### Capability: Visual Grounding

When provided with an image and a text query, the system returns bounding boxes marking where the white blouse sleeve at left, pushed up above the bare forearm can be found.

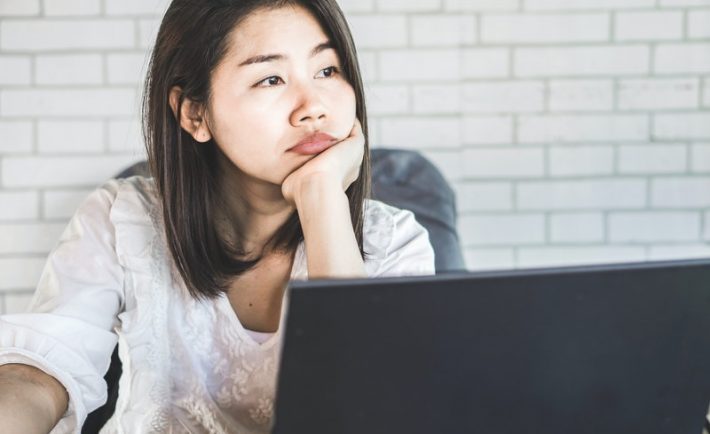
[0,181,123,434]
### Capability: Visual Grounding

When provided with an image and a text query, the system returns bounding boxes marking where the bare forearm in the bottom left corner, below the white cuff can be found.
[0,364,69,433]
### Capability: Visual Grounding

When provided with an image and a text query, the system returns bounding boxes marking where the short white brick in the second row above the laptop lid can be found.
[550,213,605,243]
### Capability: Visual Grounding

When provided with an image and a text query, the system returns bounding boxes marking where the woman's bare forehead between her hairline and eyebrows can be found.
[230,5,328,58]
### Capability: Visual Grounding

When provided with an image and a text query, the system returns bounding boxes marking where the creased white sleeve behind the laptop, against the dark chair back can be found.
[368,208,435,277]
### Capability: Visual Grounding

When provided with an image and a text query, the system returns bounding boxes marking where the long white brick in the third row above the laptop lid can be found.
[516,178,647,210]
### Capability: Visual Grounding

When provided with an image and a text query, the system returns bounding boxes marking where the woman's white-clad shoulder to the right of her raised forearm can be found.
[363,199,434,276]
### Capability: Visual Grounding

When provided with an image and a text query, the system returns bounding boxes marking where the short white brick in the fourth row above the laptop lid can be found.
[548,146,614,176]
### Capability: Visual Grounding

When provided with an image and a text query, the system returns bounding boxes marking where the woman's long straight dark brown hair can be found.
[142,0,370,299]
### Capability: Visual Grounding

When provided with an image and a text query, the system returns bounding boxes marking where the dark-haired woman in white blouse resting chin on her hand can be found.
[0,0,434,433]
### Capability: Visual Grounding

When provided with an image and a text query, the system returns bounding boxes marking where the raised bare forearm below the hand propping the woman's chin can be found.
[295,175,366,279]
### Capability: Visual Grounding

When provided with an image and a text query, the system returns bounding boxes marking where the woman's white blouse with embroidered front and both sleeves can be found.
[0,177,434,434]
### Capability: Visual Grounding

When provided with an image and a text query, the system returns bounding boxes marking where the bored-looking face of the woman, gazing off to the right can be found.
[206,6,356,185]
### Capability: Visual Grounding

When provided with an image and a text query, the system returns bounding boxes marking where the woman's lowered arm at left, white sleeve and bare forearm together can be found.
[0,181,123,433]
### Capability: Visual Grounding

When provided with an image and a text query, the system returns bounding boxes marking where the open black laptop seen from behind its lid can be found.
[273,260,710,434]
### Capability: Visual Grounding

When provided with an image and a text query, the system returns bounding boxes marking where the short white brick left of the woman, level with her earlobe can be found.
[37,121,104,154]
